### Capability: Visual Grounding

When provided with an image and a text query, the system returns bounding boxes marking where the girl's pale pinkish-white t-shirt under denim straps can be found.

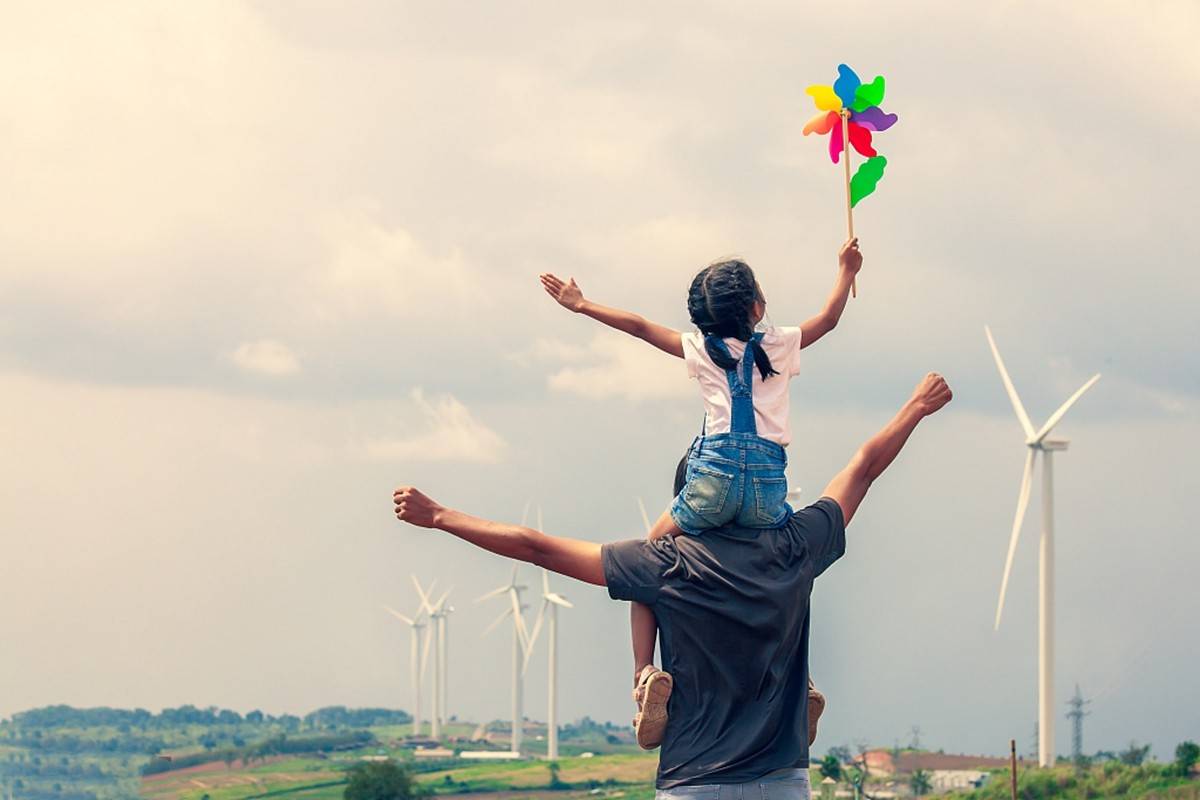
[683,327,800,447]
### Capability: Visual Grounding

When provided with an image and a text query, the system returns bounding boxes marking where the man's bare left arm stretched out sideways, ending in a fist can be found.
[392,486,605,587]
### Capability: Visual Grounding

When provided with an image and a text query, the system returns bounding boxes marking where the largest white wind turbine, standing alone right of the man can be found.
[983,325,1100,766]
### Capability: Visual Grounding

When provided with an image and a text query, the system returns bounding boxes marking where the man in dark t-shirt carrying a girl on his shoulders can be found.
[392,373,952,800]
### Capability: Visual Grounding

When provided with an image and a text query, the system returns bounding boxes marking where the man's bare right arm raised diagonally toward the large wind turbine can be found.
[824,372,954,525]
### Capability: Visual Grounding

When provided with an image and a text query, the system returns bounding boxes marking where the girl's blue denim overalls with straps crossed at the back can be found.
[671,333,792,534]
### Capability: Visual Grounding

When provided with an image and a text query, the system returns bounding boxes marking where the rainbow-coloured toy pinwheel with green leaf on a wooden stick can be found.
[804,64,898,296]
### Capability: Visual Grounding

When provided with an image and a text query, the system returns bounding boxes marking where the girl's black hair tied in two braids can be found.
[688,259,779,380]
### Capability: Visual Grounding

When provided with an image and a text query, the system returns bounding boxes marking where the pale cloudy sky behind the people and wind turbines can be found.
[0,0,1200,758]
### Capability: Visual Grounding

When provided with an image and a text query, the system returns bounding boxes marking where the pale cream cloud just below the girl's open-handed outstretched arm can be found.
[542,332,694,401]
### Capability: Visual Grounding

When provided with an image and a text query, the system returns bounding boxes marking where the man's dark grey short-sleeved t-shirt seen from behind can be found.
[604,498,846,789]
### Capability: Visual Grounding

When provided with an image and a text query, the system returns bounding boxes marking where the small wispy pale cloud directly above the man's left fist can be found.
[365,389,506,464]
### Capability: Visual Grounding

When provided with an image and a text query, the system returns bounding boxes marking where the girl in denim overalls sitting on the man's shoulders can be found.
[541,239,863,748]
